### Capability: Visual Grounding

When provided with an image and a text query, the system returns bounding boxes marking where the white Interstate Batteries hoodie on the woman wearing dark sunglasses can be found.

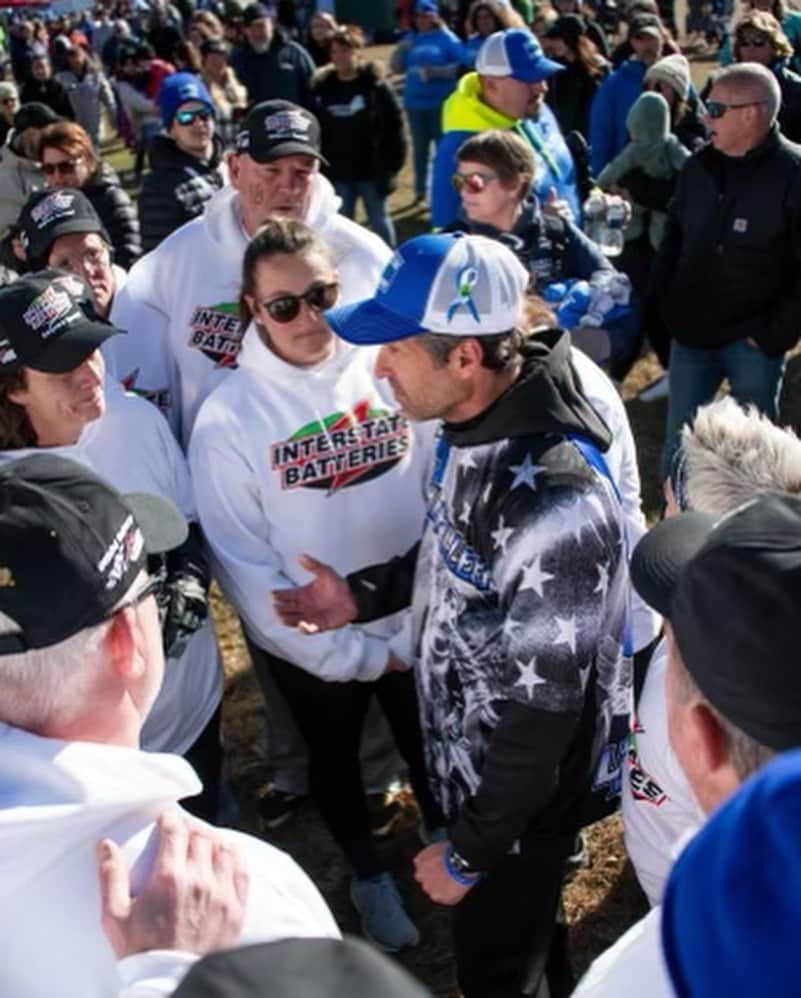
[189,325,433,681]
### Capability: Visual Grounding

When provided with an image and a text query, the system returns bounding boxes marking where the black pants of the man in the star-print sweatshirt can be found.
[453,836,574,998]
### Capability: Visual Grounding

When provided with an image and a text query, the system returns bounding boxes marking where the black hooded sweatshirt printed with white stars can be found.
[348,331,631,870]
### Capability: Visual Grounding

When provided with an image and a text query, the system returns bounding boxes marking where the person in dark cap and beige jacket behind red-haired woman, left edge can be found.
[0,104,58,236]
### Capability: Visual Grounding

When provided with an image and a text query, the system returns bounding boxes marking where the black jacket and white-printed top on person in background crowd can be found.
[311,62,406,195]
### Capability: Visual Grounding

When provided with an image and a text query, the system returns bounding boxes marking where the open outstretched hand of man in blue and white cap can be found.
[272,554,357,634]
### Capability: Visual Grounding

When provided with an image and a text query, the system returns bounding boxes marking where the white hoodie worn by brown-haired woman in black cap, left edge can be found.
[0,380,222,756]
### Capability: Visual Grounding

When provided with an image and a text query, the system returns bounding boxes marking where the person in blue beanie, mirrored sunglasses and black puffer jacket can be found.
[137,73,225,253]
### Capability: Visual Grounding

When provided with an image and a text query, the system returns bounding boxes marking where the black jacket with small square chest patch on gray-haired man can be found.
[648,126,801,357]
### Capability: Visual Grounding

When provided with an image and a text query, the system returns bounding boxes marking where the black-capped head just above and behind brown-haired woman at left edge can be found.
[18,187,117,319]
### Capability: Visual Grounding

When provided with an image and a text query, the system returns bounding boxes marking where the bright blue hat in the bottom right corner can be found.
[664,750,801,998]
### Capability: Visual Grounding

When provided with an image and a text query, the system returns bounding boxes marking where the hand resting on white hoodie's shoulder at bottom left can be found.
[97,811,249,959]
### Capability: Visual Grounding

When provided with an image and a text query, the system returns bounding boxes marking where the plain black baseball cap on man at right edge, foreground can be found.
[631,494,801,751]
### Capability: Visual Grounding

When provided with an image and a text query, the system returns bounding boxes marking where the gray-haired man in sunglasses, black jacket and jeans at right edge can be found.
[648,63,801,478]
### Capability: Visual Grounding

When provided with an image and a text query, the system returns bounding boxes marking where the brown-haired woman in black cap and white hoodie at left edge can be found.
[0,269,222,821]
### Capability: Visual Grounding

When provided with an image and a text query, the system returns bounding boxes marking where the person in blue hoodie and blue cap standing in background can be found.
[390,0,464,201]
